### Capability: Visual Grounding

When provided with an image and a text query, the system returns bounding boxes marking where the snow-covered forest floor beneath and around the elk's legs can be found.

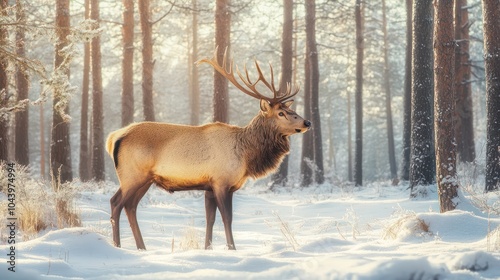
[0,182,500,280]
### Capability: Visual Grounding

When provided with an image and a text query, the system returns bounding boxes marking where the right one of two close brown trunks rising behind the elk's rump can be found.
[139,0,155,121]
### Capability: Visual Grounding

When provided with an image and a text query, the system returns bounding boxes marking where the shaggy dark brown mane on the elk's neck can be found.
[236,114,290,178]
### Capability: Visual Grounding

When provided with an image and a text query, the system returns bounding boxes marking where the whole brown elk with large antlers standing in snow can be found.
[106,49,311,250]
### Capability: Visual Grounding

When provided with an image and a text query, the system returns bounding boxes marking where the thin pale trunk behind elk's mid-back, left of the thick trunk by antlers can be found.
[190,0,200,125]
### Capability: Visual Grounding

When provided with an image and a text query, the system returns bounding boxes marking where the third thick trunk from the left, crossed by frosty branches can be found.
[50,0,73,183]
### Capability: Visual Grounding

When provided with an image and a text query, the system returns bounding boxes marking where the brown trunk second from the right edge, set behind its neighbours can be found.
[455,0,476,162]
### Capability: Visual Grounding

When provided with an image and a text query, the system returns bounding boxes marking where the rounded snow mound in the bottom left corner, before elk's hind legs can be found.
[0,228,145,279]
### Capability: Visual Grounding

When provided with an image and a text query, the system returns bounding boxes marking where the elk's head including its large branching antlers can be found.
[196,48,311,136]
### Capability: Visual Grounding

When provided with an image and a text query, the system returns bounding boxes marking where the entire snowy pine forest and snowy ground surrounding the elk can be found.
[0,0,500,279]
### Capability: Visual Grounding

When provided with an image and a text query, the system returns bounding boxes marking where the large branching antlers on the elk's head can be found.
[196,47,300,105]
